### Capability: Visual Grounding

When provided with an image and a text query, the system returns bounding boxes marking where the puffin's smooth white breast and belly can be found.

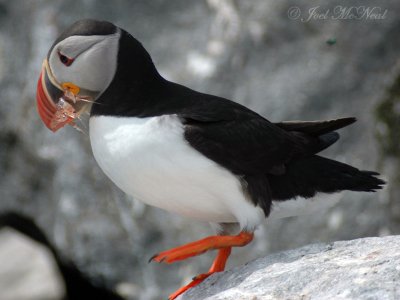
[90,115,264,229]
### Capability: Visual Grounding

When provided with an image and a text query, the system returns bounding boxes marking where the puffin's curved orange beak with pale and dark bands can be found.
[36,60,74,132]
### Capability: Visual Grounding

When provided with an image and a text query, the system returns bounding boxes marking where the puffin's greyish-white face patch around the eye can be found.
[49,31,120,92]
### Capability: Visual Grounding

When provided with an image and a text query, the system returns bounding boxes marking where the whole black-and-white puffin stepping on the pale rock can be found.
[36,19,385,299]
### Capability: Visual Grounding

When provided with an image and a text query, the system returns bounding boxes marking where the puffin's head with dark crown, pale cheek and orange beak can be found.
[36,20,121,131]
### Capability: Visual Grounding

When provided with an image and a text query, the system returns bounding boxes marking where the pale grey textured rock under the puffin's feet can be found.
[181,236,400,300]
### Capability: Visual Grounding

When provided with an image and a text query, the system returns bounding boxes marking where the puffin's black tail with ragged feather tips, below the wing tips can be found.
[268,155,385,200]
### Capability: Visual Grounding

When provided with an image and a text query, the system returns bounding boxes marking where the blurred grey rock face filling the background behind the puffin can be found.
[0,0,400,299]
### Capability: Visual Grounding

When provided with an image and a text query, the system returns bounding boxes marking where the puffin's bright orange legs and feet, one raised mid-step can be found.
[150,231,254,300]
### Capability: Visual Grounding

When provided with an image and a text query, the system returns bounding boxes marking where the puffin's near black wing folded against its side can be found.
[179,95,337,176]
